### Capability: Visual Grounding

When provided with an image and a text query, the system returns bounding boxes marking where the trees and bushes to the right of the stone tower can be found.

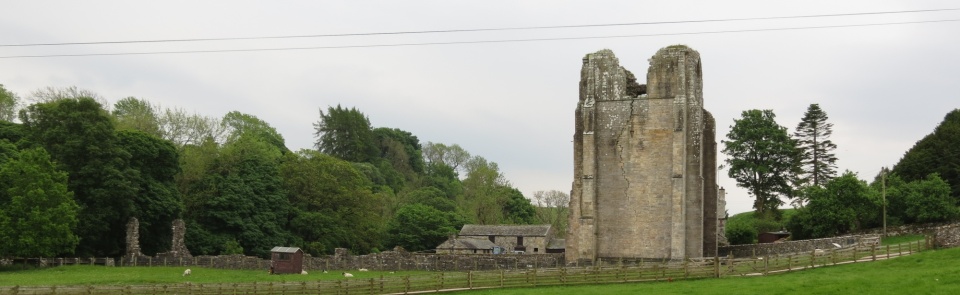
[723,104,960,244]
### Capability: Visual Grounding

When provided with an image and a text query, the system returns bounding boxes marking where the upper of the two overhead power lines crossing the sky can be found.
[0,8,960,47]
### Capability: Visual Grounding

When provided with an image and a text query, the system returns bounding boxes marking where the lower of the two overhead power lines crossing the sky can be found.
[0,19,960,59]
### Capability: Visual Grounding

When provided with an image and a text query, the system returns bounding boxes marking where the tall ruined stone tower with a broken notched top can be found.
[566,45,717,263]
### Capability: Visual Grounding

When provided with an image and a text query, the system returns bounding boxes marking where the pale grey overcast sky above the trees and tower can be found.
[0,0,960,214]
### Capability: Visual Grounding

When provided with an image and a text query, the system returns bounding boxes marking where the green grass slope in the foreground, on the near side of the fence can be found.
[455,248,960,295]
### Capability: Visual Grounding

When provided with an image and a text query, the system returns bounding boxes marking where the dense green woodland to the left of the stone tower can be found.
[0,85,569,257]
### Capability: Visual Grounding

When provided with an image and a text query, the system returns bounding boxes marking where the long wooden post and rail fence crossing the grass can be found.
[0,239,931,295]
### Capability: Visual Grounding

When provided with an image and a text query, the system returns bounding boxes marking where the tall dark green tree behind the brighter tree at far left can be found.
[20,97,137,256]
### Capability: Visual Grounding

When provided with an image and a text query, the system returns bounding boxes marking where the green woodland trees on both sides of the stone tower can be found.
[0,85,960,257]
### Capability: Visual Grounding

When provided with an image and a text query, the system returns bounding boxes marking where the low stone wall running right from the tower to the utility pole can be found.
[717,234,880,257]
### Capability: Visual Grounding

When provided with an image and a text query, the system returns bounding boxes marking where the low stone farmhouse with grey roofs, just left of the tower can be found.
[437,224,565,254]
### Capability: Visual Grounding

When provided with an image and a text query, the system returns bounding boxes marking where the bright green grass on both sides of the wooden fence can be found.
[0,236,948,295]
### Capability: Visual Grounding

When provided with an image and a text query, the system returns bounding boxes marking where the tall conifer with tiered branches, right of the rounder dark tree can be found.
[793,103,837,186]
